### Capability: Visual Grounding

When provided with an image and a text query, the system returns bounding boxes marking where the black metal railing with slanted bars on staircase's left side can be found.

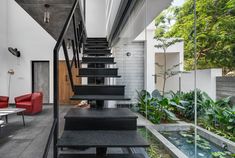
[43,0,86,158]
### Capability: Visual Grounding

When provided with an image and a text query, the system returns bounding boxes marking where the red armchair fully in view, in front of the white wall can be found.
[15,92,43,115]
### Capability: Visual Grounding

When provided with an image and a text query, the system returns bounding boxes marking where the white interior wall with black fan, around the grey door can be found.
[4,0,71,103]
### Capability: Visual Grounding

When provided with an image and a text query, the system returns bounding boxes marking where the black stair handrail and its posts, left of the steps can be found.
[43,0,86,158]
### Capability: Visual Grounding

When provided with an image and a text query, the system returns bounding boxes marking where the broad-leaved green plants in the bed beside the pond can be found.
[137,89,235,141]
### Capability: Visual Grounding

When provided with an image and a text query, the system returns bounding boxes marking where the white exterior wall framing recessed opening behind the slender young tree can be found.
[135,21,184,92]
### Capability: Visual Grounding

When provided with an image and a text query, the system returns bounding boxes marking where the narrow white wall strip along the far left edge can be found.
[0,0,8,95]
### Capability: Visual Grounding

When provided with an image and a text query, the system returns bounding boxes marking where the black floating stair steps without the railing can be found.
[58,38,148,158]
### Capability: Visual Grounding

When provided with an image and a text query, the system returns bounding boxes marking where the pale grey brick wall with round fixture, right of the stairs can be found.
[112,42,144,104]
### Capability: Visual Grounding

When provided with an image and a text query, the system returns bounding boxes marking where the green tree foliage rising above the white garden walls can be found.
[156,0,235,74]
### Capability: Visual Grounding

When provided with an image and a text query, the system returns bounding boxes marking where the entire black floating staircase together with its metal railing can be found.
[43,0,149,158]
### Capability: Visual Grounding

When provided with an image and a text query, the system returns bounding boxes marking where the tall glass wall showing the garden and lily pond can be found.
[118,0,235,158]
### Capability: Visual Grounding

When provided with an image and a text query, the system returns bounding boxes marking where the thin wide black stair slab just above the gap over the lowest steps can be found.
[70,95,130,100]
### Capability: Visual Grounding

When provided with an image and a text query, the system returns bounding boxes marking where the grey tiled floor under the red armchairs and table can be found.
[0,105,70,158]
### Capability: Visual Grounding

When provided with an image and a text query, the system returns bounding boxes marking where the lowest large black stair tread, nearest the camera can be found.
[57,130,149,147]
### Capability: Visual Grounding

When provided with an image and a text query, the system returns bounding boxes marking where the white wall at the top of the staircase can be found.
[86,0,106,37]
